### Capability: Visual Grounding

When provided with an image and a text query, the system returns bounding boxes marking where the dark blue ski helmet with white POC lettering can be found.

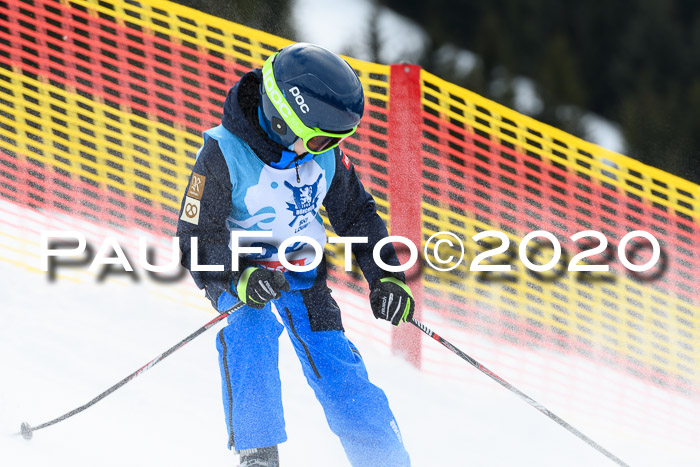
[260,42,365,147]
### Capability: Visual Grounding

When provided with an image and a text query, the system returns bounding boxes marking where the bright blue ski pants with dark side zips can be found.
[217,291,410,467]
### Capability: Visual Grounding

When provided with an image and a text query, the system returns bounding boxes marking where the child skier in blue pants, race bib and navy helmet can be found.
[178,43,414,466]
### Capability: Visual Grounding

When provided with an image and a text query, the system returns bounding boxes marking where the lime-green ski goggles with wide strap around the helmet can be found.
[263,52,357,154]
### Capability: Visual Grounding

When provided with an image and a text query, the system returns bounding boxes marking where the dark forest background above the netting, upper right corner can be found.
[379,0,700,182]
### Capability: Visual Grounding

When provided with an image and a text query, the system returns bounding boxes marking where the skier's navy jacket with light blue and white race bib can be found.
[177,69,403,326]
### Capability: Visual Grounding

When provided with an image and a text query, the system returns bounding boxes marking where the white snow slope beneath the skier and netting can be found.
[0,202,700,467]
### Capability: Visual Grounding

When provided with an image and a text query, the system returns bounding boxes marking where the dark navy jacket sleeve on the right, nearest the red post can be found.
[323,148,405,285]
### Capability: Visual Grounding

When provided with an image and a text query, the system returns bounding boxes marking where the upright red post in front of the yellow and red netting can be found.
[387,64,423,368]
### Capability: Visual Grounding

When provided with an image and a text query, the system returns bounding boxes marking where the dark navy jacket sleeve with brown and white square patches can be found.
[177,139,254,302]
